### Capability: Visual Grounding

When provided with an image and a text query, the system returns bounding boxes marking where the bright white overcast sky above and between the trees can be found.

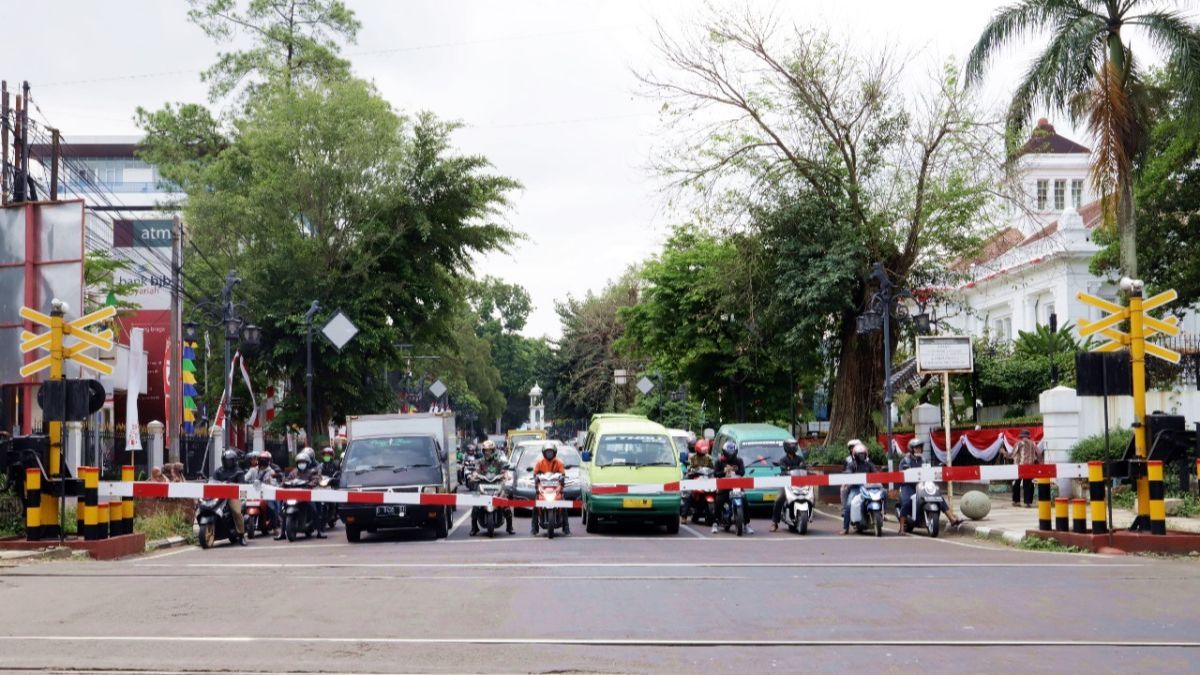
[9,0,1180,336]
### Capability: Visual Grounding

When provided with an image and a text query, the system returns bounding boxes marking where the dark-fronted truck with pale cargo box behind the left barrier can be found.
[338,413,457,542]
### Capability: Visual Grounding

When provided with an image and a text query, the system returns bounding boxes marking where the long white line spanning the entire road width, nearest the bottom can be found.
[0,635,1200,649]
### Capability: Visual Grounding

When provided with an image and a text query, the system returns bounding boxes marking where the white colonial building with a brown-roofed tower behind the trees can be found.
[946,119,1200,340]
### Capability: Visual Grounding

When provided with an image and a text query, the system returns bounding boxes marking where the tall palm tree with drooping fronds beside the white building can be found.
[966,0,1200,279]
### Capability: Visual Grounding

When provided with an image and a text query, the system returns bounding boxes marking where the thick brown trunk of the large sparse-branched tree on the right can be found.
[829,313,883,441]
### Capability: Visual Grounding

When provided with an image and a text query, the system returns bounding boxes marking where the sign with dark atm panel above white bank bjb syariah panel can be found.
[113,219,174,310]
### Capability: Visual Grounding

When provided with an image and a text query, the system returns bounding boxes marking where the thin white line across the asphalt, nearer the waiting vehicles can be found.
[139,561,1146,569]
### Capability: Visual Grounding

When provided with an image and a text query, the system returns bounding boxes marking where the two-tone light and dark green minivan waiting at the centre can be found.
[580,414,680,534]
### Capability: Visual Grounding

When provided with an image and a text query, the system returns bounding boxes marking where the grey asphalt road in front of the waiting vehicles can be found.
[0,512,1200,673]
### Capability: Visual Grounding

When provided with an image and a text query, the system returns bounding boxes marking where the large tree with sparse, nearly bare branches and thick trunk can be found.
[643,12,997,436]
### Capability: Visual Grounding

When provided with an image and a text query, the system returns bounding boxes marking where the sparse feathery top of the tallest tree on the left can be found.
[187,0,362,101]
